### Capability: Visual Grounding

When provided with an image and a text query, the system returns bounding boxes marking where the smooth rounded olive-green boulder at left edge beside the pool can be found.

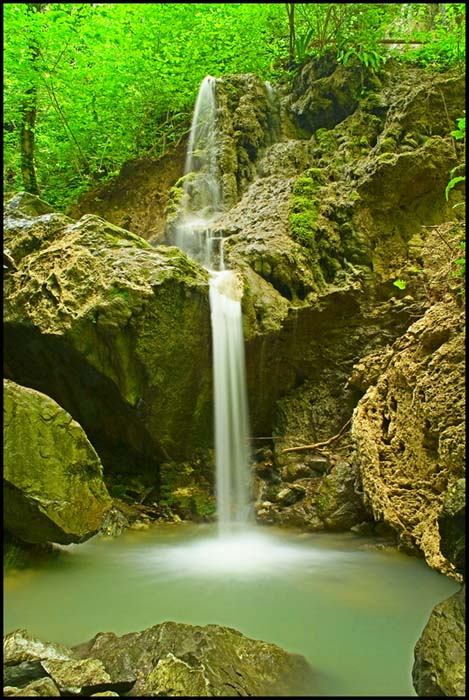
[3,380,111,544]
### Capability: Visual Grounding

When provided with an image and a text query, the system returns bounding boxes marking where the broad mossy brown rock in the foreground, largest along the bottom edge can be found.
[74,622,312,697]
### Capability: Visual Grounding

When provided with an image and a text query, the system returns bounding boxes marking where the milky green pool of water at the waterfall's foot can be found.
[4,524,459,697]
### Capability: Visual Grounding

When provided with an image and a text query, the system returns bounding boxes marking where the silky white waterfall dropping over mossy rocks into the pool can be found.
[176,76,251,534]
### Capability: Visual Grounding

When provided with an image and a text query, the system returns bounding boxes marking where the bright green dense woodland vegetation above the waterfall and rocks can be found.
[4,3,465,209]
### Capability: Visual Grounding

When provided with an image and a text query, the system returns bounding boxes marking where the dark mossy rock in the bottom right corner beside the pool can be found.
[412,587,466,697]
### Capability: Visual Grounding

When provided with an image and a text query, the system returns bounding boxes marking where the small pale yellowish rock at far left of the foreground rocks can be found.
[3,629,76,666]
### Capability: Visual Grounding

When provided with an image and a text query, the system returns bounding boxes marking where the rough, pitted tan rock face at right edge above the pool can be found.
[352,296,465,574]
